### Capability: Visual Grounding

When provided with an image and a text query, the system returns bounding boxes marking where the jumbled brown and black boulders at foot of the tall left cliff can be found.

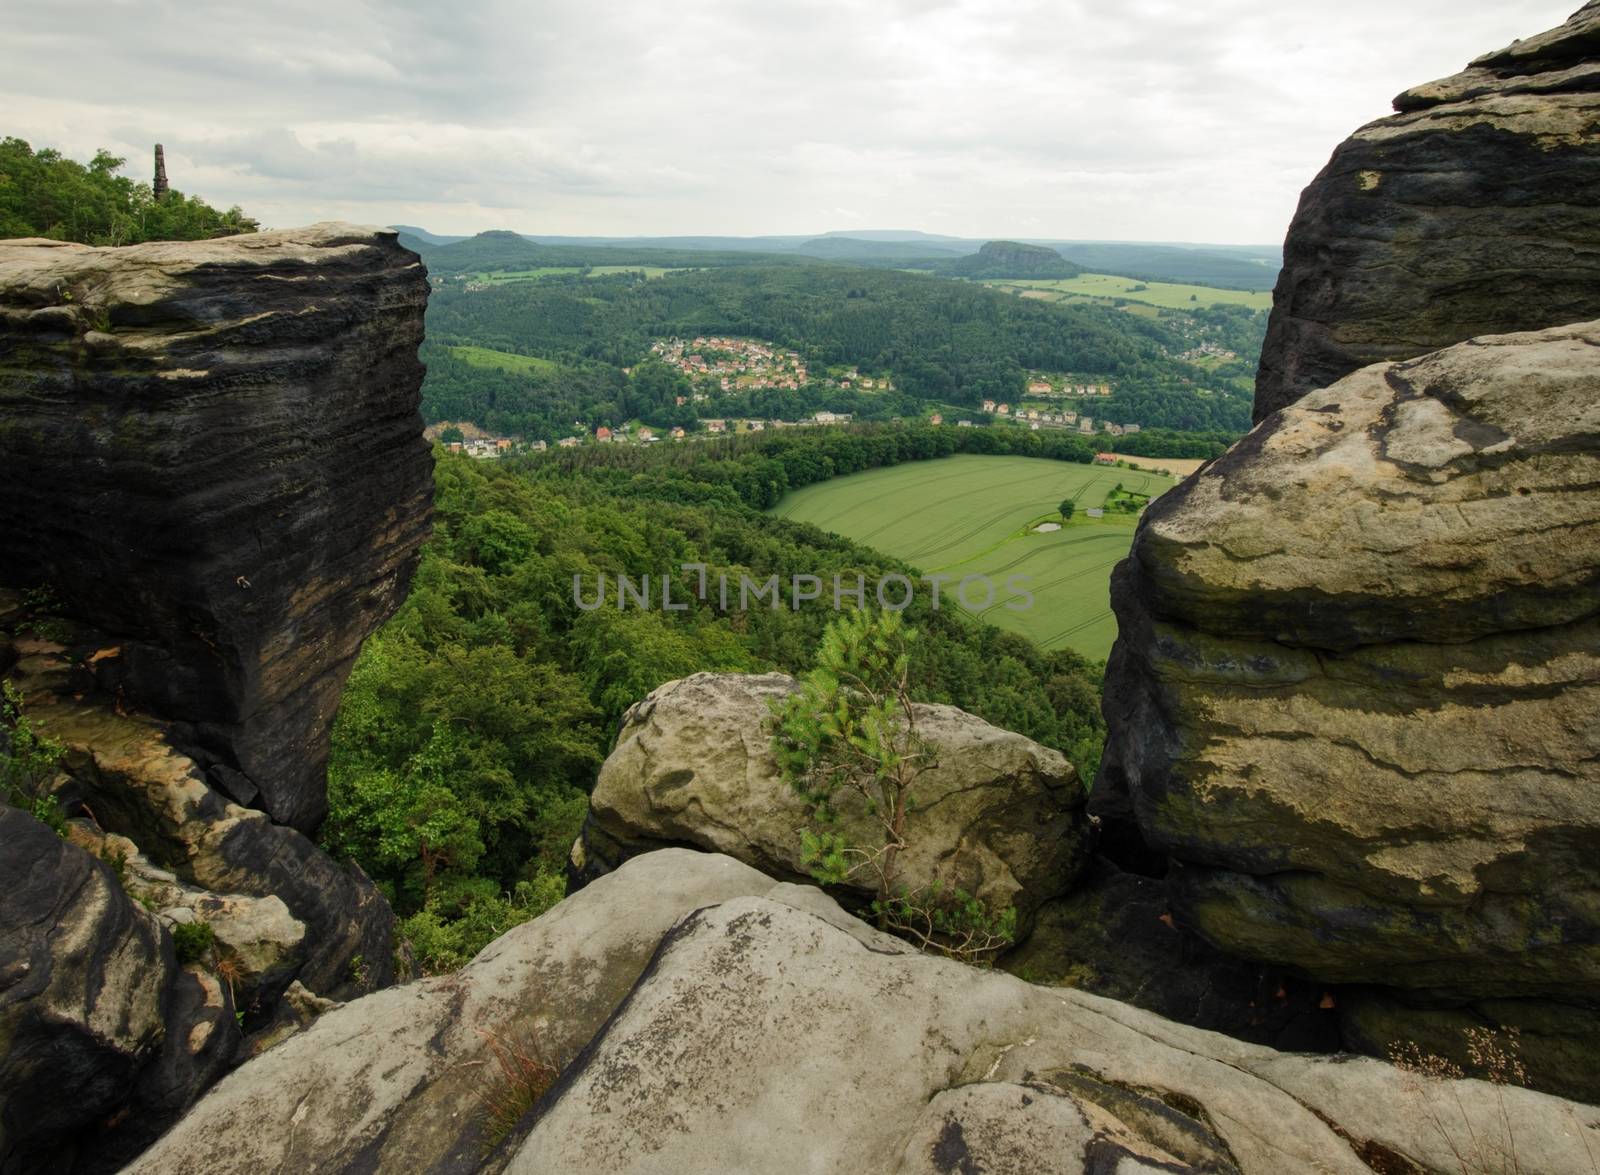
[0,591,395,1175]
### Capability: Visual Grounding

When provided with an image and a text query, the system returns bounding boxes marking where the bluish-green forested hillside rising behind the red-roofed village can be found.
[429,263,1248,427]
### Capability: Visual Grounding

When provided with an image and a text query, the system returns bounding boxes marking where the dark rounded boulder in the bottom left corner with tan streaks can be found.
[0,804,238,1172]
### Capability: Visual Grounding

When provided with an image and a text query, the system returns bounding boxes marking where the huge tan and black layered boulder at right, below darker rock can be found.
[1091,323,1600,1098]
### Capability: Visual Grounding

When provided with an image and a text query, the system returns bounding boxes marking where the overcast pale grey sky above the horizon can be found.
[0,0,1579,243]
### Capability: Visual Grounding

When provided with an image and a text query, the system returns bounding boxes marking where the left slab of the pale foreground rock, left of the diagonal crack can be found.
[121,850,796,1172]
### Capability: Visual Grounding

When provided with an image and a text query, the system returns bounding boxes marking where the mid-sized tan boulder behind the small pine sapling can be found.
[574,674,1088,924]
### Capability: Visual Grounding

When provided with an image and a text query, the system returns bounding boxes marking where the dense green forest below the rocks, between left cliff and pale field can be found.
[323,427,1102,970]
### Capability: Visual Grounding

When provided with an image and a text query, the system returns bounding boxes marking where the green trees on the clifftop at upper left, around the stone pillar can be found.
[0,138,256,245]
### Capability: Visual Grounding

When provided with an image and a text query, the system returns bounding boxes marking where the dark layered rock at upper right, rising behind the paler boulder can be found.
[1256,3,1600,421]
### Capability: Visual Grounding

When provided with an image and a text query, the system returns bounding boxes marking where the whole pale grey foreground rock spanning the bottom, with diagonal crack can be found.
[130,850,1600,1175]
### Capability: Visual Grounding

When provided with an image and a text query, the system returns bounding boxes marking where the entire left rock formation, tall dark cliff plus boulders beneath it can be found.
[0,226,430,1175]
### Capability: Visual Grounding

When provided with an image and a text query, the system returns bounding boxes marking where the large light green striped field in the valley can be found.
[773,455,1176,660]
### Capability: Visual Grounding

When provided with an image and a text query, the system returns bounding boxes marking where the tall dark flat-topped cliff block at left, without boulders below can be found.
[0,224,432,831]
